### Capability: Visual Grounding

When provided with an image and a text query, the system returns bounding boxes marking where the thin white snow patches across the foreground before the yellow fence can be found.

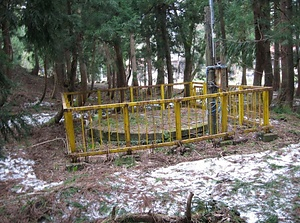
[0,143,300,223]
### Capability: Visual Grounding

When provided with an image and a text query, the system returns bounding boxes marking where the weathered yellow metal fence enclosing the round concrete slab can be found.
[62,82,270,157]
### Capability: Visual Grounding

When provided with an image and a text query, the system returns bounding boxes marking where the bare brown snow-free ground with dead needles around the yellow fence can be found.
[0,69,300,222]
